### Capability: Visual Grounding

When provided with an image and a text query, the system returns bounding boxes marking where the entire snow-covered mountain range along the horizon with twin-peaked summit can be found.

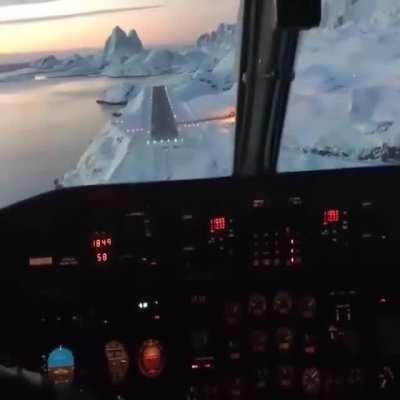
[0,24,239,84]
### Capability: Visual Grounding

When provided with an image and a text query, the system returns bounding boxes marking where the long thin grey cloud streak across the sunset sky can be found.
[0,4,163,25]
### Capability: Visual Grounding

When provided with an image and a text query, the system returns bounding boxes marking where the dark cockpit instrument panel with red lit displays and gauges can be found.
[0,167,400,400]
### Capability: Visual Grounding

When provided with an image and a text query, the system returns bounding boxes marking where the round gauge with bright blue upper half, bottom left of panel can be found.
[47,346,75,385]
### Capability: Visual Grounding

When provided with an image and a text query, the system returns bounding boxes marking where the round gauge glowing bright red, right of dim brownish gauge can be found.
[138,339,166,379]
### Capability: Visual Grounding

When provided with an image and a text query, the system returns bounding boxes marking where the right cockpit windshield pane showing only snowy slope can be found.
[278,0,400,172]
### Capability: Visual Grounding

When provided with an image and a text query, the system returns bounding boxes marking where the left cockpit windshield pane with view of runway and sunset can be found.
[0,0,241,207]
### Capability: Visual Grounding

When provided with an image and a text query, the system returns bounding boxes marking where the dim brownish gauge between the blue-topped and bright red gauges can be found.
[105,341,129,385]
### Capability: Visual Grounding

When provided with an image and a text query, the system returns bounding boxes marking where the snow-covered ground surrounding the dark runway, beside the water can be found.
[62,80,236,186]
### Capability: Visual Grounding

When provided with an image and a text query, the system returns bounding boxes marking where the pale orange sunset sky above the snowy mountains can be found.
[0,0,240,60]
